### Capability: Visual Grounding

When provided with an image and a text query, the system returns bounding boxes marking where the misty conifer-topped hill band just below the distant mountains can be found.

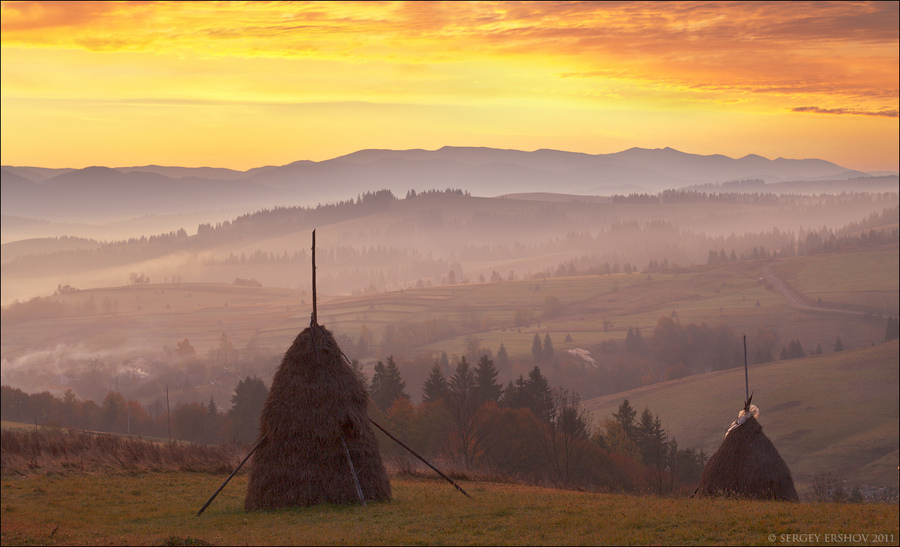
[2,188,897,304]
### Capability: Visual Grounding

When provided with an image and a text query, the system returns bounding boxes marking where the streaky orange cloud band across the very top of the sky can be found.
[2,2,900,109]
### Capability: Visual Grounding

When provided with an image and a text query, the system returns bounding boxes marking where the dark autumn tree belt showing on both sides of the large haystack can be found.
[2,355,706,493]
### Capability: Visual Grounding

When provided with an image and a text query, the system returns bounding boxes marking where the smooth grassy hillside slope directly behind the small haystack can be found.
[585,340,900,491]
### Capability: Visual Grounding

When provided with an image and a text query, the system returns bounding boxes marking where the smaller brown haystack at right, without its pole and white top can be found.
[695,417,799,501]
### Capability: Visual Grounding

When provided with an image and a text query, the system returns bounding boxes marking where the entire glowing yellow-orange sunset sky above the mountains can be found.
[0,2,900,171]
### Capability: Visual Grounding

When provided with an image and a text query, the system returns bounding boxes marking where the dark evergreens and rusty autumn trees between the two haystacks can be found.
[342,354,706,493]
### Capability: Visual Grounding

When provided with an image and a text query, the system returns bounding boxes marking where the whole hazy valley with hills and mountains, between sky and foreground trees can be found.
[2,147,900,492]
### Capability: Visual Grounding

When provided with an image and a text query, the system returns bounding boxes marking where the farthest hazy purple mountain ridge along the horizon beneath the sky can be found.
[2,146,892,221]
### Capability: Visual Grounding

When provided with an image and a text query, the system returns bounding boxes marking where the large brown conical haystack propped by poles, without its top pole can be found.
[244,325,391,511]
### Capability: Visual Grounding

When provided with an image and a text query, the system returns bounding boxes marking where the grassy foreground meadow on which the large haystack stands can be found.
[0,473,900,545]
